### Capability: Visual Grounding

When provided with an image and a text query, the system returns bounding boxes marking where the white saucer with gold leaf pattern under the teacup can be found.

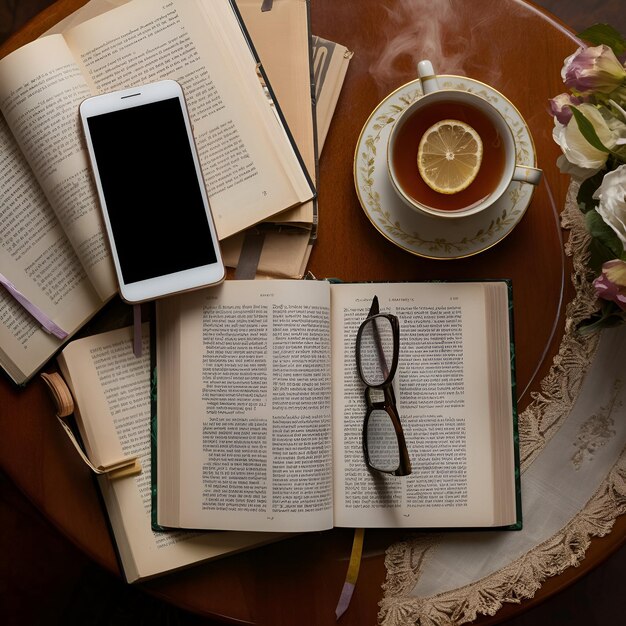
[354,76,536,259]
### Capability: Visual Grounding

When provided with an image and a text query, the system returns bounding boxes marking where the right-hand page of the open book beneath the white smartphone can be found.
[64,0,313,238]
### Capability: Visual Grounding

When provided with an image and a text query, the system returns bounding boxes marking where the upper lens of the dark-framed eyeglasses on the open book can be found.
[359,317,394,386]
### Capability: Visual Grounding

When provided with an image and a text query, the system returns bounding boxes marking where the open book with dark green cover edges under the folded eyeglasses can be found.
[153,280,521,532]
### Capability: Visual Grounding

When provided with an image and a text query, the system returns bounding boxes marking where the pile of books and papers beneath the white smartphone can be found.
[0,0,349,384]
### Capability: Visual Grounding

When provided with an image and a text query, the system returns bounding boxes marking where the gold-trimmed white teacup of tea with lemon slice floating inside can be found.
[387,60,542,218]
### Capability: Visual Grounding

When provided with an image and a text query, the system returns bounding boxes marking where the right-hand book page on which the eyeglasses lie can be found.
[331,283,515,528]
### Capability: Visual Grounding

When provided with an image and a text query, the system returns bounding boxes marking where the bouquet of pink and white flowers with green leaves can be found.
[550,24,626,332]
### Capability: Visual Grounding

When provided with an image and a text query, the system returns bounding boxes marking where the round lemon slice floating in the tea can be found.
[417,120,483,194]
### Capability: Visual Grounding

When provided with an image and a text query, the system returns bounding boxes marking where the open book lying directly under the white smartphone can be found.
[0,0,314,382]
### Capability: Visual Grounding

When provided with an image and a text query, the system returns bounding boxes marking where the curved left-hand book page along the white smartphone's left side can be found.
[0,35,117,300]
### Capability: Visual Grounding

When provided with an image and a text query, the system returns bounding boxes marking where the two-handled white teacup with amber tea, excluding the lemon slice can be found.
[387,60,542,218]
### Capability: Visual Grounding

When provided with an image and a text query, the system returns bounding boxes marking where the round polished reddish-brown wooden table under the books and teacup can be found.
[0,0,626,625]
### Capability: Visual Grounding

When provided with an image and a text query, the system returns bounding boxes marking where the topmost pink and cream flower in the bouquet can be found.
[561,44,626,94]
